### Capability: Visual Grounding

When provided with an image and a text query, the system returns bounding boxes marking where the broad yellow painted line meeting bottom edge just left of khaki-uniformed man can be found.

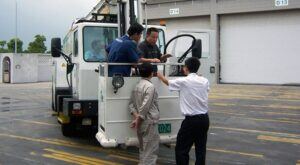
[44,148,119,165]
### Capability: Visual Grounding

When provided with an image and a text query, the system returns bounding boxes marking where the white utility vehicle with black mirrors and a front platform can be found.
[51,0,202,147]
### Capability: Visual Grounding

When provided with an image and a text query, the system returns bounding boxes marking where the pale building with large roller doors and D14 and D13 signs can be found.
[94,0,300,84]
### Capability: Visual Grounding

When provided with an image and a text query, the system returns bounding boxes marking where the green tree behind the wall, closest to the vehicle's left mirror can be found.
[26,35,47,53]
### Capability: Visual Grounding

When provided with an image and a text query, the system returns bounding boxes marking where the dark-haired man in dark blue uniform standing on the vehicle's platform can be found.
[106,23,144,77]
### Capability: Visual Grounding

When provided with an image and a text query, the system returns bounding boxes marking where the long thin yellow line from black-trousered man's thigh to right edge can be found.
[210,126,300,138]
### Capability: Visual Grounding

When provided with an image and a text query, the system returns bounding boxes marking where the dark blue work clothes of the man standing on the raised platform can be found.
[106,35,139,77]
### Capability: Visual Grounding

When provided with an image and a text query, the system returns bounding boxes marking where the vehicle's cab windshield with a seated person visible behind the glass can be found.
[83,26,118,62]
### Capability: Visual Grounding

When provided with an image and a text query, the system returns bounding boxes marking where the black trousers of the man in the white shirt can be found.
[175,114,209,165]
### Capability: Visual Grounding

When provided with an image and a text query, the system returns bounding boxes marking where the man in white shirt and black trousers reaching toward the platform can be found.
[157,57,209,165]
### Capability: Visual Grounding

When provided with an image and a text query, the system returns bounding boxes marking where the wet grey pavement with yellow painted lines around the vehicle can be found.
[0,83,300,165]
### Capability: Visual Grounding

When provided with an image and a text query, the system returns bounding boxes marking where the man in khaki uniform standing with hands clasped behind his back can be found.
[129,63,159,165]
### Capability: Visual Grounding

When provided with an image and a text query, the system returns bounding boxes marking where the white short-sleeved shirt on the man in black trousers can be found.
[169,73,209,116]
